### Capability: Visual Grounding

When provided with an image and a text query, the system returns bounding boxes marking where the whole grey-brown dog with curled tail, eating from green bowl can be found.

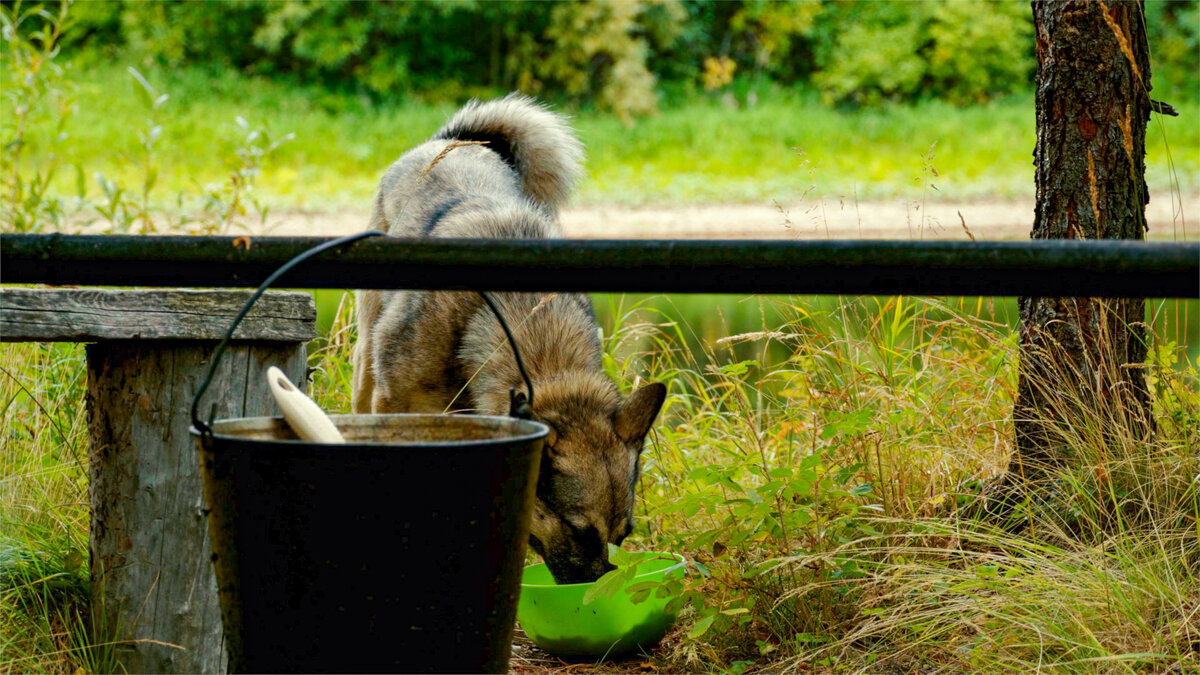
[352,95,666,584]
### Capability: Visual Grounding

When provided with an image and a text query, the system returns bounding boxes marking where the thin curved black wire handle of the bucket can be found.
[191,229,533,438]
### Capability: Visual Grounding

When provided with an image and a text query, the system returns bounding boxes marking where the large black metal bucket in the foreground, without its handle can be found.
[193,414,548,673]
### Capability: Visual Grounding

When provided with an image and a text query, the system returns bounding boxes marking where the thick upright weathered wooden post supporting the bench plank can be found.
[88,340,306,673]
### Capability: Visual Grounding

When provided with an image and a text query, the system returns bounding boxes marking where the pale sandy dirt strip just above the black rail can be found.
[268,193,1200,240]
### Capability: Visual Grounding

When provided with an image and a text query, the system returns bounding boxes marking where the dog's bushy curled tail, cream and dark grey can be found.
[433,94,583,208]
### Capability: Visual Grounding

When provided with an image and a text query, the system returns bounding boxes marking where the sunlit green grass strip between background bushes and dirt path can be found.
[28,61,1200,209]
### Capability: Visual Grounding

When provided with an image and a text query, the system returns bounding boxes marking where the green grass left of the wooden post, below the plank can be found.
[0,345,94,673]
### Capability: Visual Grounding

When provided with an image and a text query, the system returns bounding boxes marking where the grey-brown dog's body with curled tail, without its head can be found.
[353,95,599,414]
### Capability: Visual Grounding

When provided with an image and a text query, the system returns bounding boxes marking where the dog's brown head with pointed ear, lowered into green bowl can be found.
[529,380,666,584]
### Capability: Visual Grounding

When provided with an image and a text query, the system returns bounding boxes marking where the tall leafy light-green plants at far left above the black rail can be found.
[0,2,293,233]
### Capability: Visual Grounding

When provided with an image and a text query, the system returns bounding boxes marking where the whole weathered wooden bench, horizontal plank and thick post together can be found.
[0,288,316,673]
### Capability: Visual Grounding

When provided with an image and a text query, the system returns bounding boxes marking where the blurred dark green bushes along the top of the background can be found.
[54,0,1200,115]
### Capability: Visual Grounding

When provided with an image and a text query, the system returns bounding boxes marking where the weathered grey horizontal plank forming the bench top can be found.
[0,288,317,342]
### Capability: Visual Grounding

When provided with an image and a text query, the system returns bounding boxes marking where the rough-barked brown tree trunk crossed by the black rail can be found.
[1012,0,1153,478]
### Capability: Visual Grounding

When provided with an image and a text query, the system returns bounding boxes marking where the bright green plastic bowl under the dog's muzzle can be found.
[517,551,684,658]
